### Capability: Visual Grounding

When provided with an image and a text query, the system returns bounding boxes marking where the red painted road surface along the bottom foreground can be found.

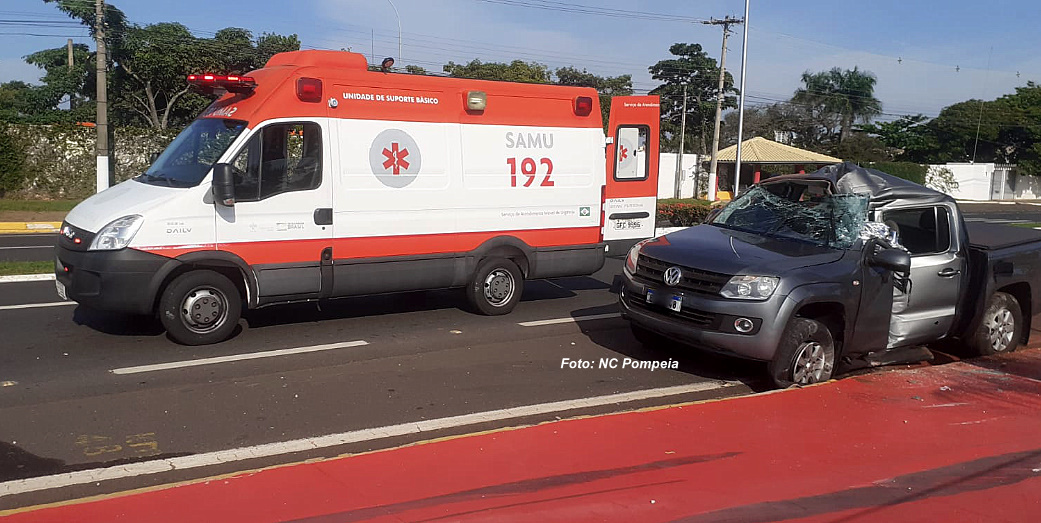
[2,350,1041,522]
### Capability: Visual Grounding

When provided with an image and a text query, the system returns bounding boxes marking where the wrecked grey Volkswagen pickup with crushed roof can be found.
[619,164,1041,387]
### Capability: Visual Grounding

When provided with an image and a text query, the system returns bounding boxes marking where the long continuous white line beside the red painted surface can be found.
[0,381,739,497]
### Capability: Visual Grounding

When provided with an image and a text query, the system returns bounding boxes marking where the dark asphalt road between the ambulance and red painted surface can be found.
[0,259,765,508]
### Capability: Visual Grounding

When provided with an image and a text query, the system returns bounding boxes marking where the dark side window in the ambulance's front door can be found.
[232,123,322,201]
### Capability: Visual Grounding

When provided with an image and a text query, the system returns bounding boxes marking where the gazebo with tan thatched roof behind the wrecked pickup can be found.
[703,136,842,197]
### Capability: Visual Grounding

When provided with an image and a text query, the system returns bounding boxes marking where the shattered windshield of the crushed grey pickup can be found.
[711,183,868,249]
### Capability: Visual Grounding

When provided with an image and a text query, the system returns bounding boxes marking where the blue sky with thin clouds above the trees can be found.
[0,0,1041,120]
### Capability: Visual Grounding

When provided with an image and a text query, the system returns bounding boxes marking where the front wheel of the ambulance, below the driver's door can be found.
[159,271,243,345]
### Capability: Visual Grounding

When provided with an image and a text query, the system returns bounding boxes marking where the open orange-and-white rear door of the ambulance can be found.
[603,96,661,255]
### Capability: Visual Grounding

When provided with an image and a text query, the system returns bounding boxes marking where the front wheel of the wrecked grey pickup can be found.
[769,318,835,389]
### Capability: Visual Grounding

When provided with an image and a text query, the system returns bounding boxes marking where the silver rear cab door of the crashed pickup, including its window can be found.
[882,204,966,348]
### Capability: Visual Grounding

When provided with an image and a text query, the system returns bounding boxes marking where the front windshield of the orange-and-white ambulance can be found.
[134,118,246,188]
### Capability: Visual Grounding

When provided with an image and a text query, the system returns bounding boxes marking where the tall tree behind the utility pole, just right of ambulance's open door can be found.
[649,44,737,154]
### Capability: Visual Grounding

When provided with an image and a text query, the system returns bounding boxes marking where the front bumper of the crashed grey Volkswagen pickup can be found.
[618,273,788,362]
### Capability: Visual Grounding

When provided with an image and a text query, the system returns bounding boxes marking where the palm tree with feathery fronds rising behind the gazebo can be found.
[791,67,882,143]
